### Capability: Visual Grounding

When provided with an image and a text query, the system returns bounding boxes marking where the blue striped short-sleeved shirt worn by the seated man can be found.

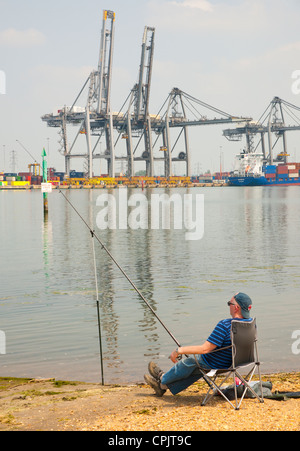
[202,318,252,369]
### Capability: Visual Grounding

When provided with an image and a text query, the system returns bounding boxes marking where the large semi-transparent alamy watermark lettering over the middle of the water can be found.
[96,188,204,241]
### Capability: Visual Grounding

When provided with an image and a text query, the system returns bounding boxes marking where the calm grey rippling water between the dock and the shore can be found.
[0,187,300,383]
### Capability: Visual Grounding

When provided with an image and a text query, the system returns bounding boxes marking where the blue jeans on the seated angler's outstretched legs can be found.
[161,355,210,395]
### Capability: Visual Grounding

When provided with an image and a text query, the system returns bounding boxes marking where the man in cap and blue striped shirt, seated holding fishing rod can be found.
[144,293,252,396]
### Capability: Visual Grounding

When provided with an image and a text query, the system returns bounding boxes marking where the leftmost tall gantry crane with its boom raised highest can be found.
[42,10,115,177]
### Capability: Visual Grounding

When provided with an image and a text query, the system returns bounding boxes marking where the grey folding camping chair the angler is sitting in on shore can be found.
[199,319,264,410]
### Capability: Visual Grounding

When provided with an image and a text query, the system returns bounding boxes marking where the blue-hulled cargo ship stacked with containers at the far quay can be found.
[228,152,300,186]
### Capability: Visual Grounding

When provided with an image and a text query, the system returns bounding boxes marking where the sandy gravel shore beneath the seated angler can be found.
[0,373,300,431]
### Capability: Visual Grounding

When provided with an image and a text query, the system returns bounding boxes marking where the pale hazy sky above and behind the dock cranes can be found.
[0,0,300,172]
